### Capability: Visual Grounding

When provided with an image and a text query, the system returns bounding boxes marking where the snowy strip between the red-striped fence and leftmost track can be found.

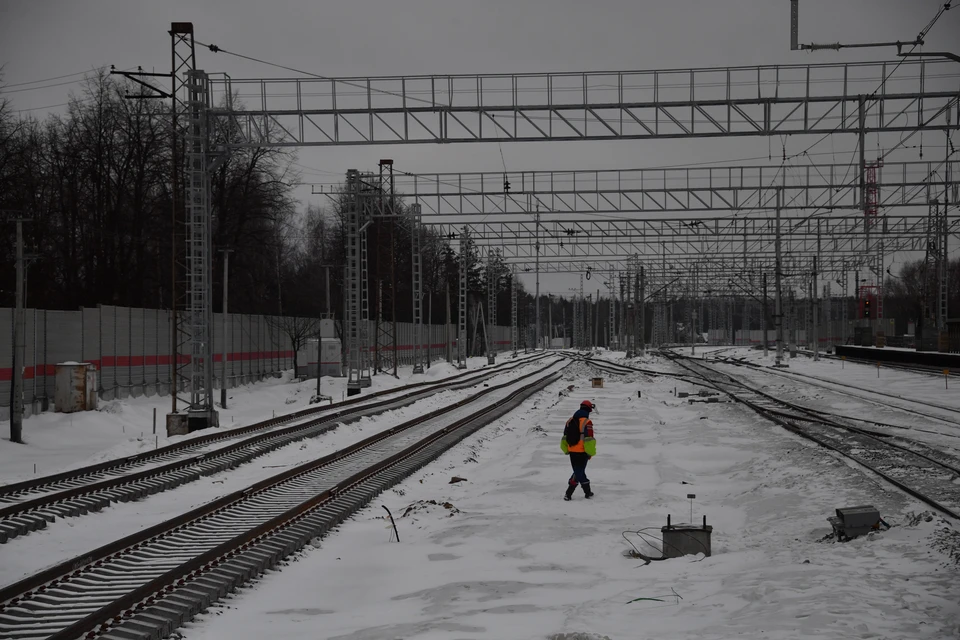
[0,358,503,484]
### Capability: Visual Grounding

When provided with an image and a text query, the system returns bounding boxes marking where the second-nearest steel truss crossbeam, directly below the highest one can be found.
[396,160,960,220]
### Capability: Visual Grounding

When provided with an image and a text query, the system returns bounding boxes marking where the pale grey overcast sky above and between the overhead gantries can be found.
[0,0,960,292]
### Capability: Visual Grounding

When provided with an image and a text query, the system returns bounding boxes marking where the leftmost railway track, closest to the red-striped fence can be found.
[0,356,544,544]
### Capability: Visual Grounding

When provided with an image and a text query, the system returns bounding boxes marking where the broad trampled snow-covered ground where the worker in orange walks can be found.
[171,354,960,640]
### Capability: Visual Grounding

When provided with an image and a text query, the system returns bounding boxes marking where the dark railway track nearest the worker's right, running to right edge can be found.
[668,354,960,519]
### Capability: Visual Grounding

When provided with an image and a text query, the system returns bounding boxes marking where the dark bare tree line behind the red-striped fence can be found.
[0,70,529,340]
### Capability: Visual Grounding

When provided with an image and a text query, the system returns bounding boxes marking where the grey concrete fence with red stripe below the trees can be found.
[0,305,510,418]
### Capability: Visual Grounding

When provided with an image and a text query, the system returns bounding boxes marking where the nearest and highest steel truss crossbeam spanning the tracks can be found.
[206,59,960,146]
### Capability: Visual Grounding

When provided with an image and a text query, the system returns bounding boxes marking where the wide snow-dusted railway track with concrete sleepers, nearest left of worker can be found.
[0,361,569,640]
